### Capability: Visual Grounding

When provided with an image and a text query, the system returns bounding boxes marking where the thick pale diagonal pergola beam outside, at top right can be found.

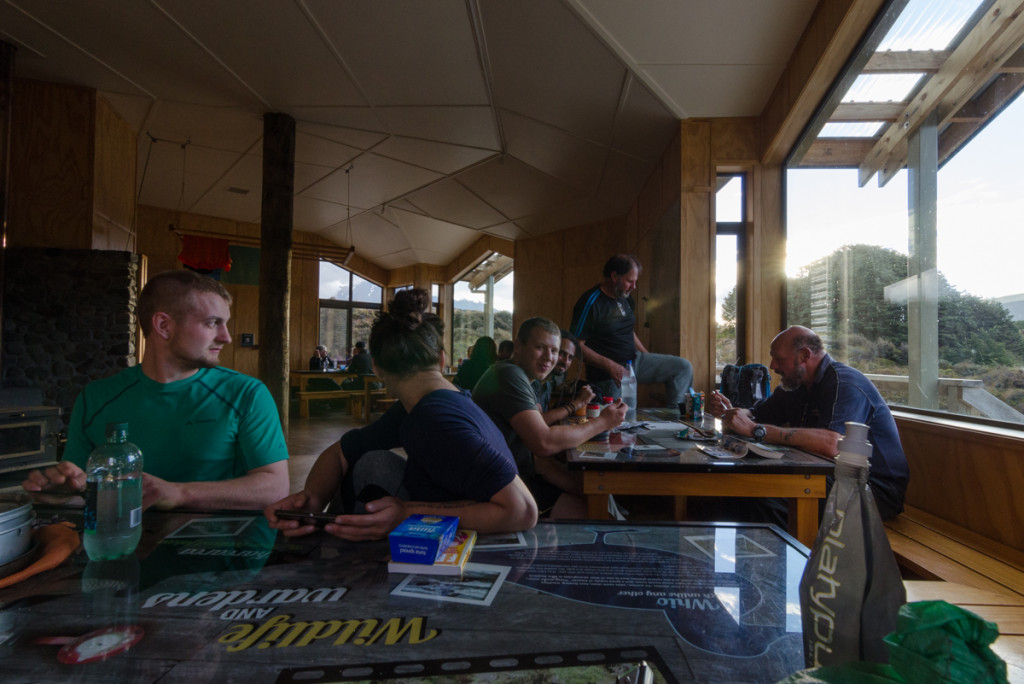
[858,0,1024,186]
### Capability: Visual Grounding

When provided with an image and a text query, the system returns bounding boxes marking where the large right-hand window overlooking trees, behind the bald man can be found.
[786,98,1024,424]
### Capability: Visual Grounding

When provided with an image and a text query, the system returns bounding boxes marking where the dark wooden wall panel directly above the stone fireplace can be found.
[7,79,95,249]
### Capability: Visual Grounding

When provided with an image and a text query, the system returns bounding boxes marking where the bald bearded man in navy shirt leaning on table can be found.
[708,326,910,520]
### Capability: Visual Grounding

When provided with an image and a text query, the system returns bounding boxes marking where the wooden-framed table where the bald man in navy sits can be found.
[566,410,835,547]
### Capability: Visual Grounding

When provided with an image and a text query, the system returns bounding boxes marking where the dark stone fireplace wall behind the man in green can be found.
[0,248,139,426]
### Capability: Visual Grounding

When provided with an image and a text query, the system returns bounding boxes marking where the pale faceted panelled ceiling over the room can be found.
[0,0,817,268]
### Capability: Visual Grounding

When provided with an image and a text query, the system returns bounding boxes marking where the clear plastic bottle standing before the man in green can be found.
[82,423,142,560]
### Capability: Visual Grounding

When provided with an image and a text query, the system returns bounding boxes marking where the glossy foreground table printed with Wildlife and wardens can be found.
[0,513,807,684]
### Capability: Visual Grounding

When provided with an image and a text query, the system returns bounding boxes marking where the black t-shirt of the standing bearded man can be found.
[569,285,637,382]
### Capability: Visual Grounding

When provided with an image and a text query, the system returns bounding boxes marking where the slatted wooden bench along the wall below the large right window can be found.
[886,506,1024,596]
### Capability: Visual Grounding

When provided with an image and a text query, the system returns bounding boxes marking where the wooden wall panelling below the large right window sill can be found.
[896,412,1024,551]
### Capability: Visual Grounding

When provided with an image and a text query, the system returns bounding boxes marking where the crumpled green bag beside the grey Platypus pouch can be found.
[885,601,1007,684]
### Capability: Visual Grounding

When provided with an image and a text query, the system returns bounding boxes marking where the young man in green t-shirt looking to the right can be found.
[23,270,289,509]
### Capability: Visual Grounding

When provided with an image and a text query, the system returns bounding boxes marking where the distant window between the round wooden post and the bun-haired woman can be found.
[319,261,382,362]
